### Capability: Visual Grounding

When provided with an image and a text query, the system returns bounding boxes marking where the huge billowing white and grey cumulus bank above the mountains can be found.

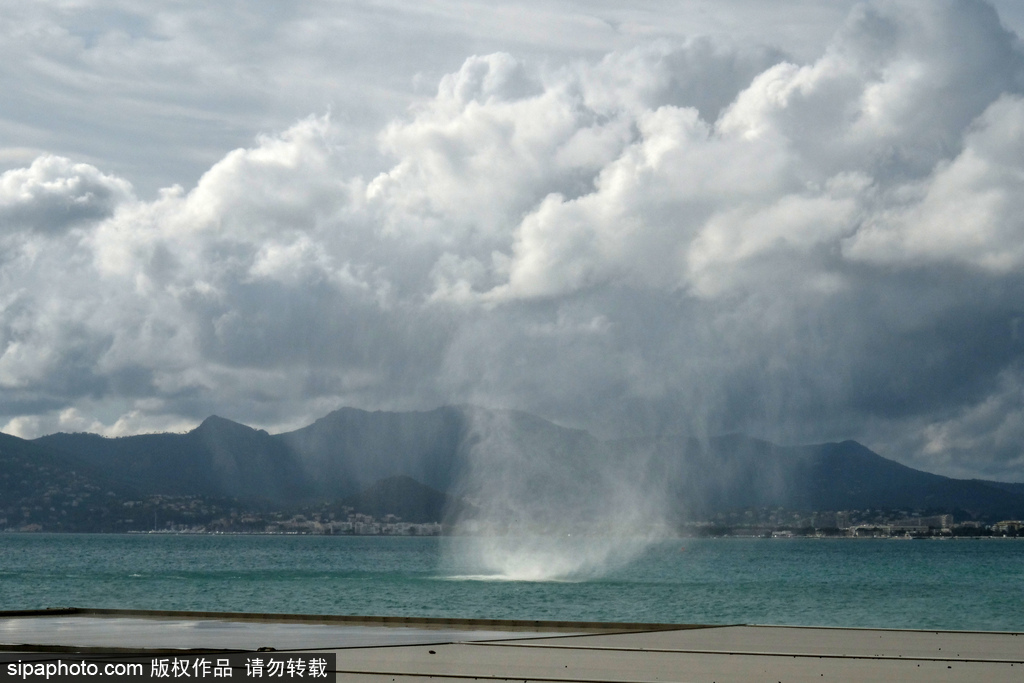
[6,0,1024,478]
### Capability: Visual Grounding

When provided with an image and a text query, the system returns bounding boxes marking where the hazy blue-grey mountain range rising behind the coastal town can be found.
[19,405,1024,519]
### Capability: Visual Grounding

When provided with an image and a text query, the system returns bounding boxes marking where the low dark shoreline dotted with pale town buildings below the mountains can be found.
[0,489,1024,539]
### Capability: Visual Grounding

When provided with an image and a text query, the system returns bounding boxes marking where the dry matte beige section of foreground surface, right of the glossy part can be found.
[325,626,1024,683]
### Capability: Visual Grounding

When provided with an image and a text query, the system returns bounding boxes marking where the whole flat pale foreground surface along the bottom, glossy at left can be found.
[0,609,1024,683]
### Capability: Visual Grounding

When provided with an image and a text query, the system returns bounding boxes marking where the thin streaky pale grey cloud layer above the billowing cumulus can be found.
[0,0,868,199]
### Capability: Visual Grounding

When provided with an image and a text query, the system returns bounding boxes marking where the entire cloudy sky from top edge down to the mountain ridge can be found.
[0,0,1024,481]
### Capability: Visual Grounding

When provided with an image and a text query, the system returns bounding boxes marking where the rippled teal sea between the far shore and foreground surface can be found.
[0,533,1024,631]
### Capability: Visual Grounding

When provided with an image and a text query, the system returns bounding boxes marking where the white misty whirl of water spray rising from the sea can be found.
[447,411,667,582]
